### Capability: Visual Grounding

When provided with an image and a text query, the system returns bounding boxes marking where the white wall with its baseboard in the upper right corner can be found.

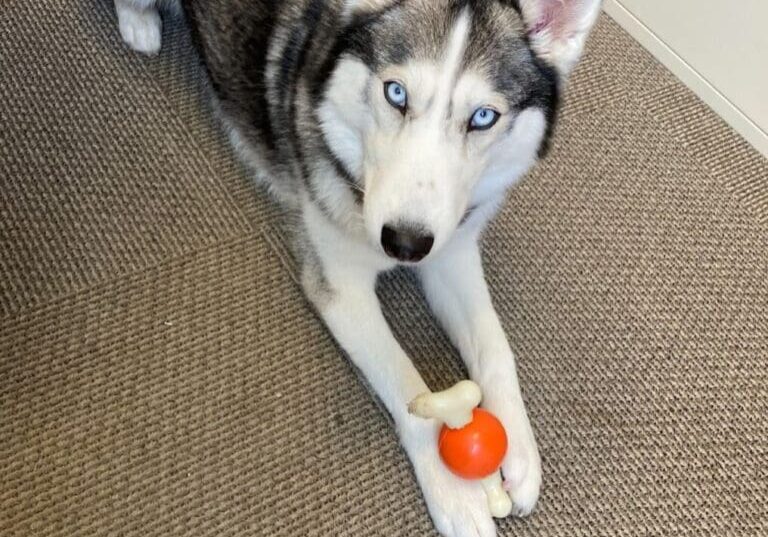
[605,0,768,156]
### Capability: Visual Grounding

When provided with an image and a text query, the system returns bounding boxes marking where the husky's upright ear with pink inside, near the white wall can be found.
[519,0,602,77]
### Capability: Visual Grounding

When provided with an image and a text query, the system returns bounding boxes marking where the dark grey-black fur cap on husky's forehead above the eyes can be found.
[313,0,560,156]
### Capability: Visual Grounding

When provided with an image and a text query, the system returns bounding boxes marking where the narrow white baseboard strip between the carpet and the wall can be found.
[603,0,768,157]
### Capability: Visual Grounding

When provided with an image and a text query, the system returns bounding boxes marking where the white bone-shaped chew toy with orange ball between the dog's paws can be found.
[408,380,512,518]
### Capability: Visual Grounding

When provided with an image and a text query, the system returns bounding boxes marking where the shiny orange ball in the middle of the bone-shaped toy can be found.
[438,408,507,479]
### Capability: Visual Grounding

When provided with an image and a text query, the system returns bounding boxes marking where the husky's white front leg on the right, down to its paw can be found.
[419,234,541,516]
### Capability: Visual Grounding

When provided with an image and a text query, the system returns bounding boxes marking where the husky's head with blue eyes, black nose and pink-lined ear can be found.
[320,0,600,262]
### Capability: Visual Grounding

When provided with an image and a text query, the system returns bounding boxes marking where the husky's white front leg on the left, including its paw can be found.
[302,219,496,537]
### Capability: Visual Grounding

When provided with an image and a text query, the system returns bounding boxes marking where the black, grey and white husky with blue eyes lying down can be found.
[115,0,600,537]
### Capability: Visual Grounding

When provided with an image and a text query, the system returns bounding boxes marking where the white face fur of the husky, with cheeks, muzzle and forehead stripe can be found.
[320,10,546,260]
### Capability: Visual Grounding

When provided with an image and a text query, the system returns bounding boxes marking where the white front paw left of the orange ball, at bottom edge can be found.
[411,446,496,537]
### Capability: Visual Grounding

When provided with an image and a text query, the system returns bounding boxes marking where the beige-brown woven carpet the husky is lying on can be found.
[0,0,768,537]
